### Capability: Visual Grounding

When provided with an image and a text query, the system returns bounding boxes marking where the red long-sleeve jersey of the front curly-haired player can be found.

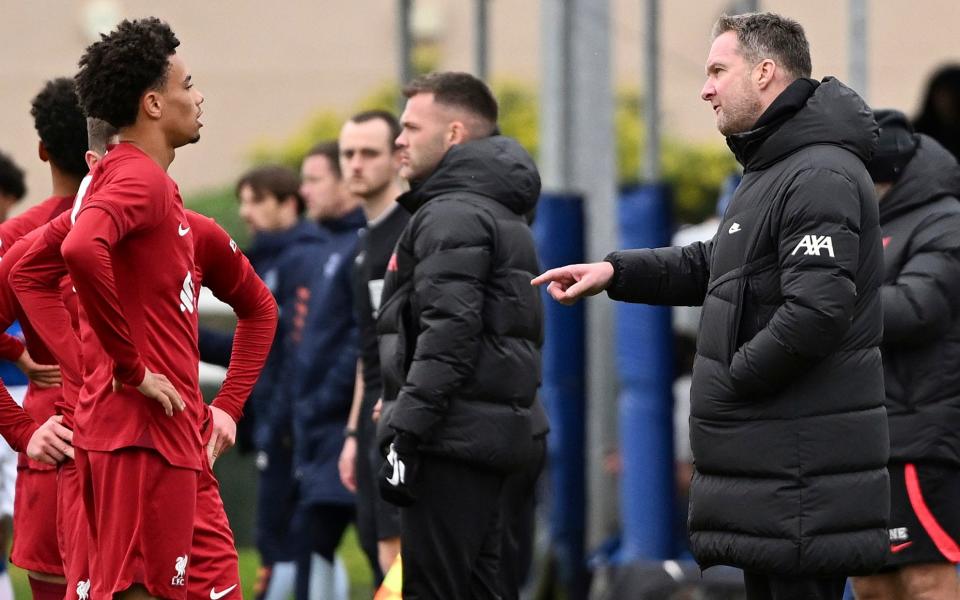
[60,143,204,469]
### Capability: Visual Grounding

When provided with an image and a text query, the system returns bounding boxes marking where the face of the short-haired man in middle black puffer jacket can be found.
[397,93,456,181]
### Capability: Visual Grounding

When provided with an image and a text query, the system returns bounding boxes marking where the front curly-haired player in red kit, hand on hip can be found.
[61,18,204,598]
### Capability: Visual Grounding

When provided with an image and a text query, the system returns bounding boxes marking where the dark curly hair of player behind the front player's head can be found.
[30,77,87,177]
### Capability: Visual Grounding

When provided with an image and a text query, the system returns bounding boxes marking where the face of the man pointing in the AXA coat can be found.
[700,31,763,136]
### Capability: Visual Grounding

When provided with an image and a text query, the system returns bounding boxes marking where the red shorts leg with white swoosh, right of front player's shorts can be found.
[187,455,243,600]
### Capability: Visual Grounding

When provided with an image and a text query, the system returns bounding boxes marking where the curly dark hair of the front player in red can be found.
[76,17,180,128]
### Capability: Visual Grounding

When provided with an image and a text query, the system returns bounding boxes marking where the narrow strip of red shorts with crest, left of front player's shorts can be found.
[57,460,90,600]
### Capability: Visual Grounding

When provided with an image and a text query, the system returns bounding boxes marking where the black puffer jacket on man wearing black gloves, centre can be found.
[377,136,546,471]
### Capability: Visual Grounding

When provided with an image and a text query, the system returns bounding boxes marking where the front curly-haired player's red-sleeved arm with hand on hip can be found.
[60,190,186,416]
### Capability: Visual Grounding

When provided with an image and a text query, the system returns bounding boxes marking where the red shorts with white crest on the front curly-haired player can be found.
[76,448,199,599]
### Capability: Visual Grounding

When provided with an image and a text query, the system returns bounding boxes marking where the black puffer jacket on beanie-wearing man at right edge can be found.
[880,135,960,466]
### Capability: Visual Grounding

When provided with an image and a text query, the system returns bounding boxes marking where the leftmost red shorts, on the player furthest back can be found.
[10,461,63,575]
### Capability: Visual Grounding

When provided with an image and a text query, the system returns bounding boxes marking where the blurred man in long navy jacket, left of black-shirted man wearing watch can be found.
[282,142,367,600]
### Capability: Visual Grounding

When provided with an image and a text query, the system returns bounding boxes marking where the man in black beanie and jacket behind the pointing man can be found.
[854,110,960,600]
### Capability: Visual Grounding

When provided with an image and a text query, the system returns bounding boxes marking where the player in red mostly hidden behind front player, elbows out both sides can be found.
[9,119,277,600]
